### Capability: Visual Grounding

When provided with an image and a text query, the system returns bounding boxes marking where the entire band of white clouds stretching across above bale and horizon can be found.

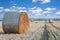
[0,6,60,18]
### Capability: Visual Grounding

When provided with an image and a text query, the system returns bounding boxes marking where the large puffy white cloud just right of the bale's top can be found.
[29,7,43,17]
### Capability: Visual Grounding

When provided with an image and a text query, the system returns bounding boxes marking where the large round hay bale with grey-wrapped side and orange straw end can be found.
[2,12,29,34]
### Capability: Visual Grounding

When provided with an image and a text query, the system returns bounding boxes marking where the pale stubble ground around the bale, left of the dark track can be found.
[0,21,45,40]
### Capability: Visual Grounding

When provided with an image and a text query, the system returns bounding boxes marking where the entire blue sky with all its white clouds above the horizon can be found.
[0,0,60,19]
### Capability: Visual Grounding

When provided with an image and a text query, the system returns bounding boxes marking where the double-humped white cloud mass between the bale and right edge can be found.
[29,6,56,18]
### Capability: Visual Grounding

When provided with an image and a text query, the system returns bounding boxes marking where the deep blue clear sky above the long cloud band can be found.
[0,0,60,9]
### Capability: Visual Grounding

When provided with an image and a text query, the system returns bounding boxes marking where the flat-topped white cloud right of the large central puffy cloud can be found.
[43,7,57,18]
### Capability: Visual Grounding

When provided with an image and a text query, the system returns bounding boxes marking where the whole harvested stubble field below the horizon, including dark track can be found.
[0,20,60,40]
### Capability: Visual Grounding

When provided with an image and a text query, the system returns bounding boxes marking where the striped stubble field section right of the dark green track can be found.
[47,21,60,40]
